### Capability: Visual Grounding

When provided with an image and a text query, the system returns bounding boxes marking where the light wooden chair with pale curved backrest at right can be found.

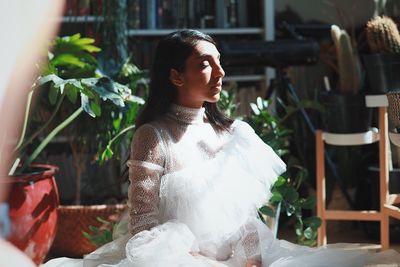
[315,95,400,250]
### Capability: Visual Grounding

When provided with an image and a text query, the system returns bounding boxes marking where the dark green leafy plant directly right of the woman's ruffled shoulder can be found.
[248,97,321,246]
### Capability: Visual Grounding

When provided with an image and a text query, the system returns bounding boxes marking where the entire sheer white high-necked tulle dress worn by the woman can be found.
[45,105,400,267]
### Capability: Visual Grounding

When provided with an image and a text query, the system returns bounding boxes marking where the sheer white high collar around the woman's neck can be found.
[168,103,205,124]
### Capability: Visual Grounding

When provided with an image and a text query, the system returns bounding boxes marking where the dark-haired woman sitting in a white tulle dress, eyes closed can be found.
[46,30,400,267]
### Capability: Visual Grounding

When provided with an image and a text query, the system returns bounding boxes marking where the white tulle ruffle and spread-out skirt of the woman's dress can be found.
[44,122,400,267]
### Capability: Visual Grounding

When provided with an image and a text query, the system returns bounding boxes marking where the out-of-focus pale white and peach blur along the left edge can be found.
[0,0,64,266]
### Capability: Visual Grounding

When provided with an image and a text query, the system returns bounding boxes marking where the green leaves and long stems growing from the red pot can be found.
[10,34,143,178]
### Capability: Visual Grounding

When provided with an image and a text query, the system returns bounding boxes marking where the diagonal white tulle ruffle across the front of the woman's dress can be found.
[160,121,285,258]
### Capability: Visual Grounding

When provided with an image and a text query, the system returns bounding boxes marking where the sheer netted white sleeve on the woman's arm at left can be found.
[128,124,165,235]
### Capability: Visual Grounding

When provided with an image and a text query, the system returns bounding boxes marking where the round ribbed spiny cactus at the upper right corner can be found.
[366,16,400,53]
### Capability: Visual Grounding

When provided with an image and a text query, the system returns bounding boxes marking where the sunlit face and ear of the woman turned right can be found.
[171,41,225,108]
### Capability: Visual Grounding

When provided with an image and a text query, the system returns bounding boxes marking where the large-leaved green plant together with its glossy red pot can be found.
[2,34,143,264]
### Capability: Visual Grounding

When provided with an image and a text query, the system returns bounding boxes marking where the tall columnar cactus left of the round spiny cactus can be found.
[331,25,361,95]
